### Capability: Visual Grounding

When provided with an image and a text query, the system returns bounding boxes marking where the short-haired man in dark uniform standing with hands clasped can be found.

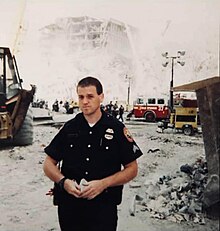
[43,77,142,231]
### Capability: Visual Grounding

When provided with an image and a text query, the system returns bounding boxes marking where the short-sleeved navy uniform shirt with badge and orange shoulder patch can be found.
[45,111,142,204]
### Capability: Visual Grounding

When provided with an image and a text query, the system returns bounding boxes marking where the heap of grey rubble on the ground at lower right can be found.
[135,158,208,224]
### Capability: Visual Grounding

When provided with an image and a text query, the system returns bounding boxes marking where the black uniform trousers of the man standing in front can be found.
[58,200,118,231]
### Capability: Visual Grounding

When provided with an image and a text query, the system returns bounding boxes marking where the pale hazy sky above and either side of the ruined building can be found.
[0,0,220,104]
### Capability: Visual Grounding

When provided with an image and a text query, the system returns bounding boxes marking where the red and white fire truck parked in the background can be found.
[127,97,170,122]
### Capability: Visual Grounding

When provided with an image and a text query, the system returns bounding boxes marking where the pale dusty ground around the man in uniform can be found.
[0,115,219,231]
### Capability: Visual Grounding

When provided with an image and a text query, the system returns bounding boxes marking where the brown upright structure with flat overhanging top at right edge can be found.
[173,77,220,218]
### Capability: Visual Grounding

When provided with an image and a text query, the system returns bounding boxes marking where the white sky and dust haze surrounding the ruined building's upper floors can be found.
[0,0,220,106]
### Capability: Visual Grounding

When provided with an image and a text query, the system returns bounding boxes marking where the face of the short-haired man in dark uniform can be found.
[77,86,104,115]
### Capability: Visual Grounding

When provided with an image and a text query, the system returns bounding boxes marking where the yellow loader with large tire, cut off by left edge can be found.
[0,47,35,145]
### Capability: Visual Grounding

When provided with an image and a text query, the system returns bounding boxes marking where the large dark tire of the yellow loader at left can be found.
[12,108,34,146]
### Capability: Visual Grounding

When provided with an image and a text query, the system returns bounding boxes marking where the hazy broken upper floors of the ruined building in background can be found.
[40,16,138,58]
